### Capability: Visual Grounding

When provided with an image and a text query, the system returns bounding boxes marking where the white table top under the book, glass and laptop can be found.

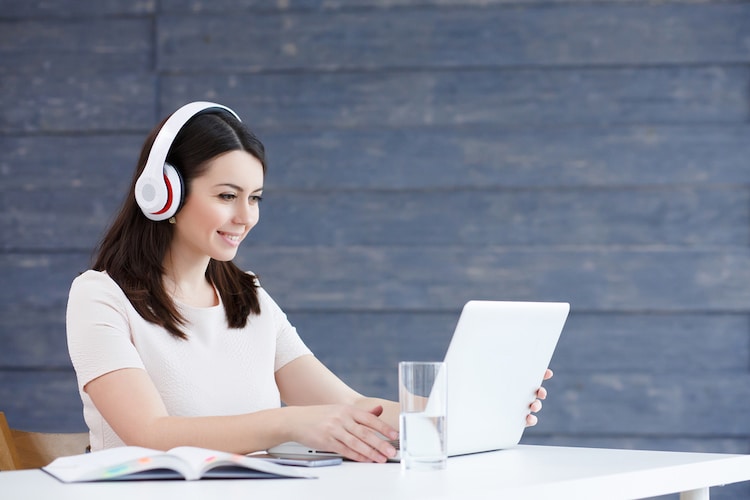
[0,446,750,500]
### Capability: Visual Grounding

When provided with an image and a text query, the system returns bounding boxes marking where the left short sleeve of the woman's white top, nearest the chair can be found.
[66,271,144,389]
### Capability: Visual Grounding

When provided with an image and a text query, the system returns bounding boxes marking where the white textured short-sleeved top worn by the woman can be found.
[67,271,310,450]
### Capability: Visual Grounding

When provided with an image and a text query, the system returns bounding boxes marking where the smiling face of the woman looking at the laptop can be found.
[171,151,263,261]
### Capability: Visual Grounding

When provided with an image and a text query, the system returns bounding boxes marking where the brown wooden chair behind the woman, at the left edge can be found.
[0,411,89,470]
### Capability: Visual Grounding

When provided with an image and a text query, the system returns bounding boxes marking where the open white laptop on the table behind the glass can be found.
[268,300,570,456]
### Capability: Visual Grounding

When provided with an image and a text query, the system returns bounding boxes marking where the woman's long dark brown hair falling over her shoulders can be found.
[93,110,266,339]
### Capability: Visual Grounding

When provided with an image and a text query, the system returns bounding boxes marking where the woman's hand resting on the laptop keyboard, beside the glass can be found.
[289,404,398,463]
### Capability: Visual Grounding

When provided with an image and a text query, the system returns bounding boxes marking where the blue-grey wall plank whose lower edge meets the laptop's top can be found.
[0,249,750,314]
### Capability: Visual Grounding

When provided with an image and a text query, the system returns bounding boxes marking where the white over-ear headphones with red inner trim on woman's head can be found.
[135,101,241,221]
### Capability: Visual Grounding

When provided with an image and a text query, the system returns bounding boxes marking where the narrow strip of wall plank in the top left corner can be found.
[0,0,156,20]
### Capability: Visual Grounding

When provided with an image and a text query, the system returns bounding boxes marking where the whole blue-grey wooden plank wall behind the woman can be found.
[0,0,750,498]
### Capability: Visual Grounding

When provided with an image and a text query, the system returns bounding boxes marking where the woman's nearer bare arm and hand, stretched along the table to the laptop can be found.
[85,356,397,462]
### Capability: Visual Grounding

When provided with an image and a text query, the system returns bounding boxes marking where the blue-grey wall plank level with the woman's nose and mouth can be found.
[0,187,750,251]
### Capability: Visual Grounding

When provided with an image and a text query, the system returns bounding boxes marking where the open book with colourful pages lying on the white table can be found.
[42,446,315,483]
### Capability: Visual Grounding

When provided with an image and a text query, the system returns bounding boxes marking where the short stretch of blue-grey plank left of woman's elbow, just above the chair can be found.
[0,369,86,432]
